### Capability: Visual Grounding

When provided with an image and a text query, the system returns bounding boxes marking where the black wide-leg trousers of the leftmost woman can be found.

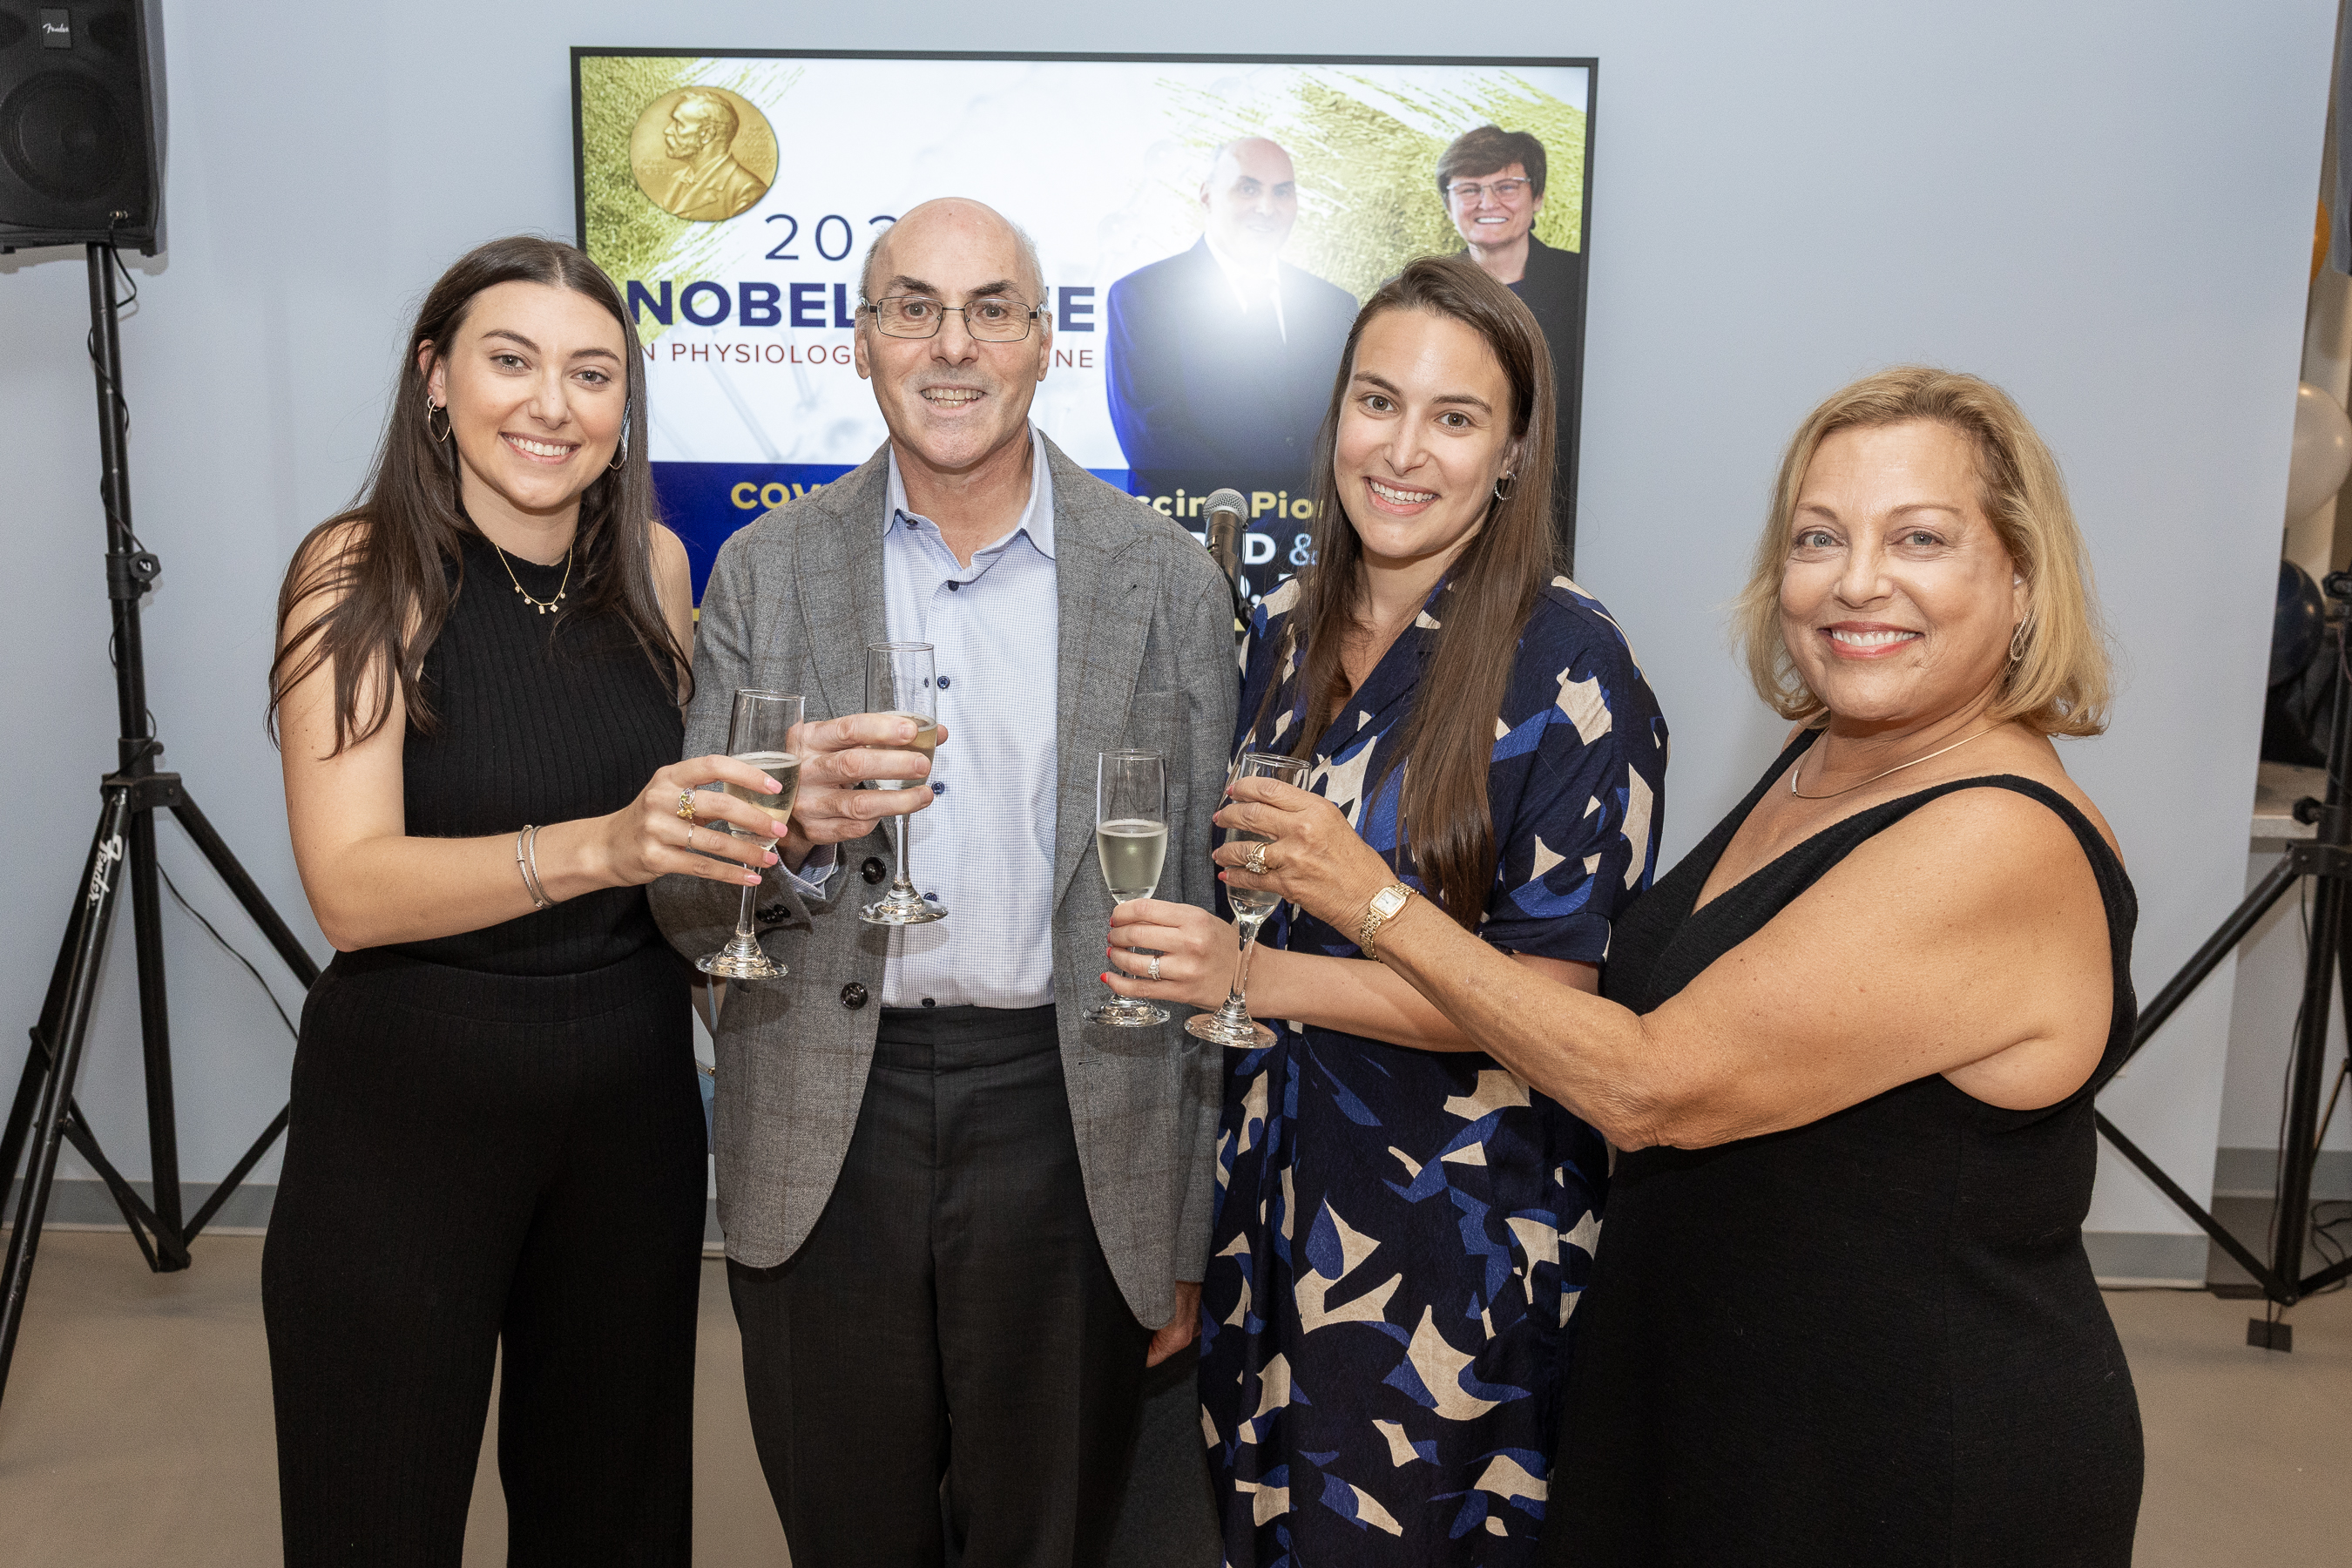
[261,950,706,1568]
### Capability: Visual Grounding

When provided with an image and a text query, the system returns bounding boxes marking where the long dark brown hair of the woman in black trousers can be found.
[271,235,689,753]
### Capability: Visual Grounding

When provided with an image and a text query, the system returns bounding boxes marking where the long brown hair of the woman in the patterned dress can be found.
[1259,256,1557,931]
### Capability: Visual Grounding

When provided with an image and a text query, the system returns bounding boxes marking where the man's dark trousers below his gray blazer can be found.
[727,1006,1150,1568]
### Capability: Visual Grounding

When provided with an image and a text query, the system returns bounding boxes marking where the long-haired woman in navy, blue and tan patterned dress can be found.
[1105,259,1666,1568]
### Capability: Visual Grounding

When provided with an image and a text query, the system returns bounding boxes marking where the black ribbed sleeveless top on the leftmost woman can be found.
[383,534,686,976]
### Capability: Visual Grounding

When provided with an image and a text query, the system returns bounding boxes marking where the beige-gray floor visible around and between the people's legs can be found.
[0,1232,2352,1568]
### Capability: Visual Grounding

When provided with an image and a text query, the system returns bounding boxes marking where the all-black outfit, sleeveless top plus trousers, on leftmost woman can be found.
[261,536,706,1568]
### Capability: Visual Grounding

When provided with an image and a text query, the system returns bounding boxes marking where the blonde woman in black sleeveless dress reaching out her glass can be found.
[1219,369,2140,1568]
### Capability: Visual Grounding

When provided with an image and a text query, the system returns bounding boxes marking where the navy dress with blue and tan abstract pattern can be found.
[1200,578,1666,1568]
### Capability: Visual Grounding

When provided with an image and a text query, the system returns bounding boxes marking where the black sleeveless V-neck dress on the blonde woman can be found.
[1545,736,2140,1568]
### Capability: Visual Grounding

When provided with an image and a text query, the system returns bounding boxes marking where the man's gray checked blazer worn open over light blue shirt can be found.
[652,442,1240,1328]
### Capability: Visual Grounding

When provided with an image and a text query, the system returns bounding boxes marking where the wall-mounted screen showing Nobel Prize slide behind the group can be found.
[571,50,1592,597]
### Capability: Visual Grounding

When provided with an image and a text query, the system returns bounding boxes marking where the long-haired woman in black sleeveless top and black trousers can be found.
[261,240,781,1568]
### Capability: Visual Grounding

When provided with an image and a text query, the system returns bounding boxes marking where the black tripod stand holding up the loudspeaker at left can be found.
[0,245,318,1396]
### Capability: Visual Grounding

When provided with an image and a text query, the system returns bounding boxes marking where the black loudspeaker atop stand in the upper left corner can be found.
[0,0,165,256]
